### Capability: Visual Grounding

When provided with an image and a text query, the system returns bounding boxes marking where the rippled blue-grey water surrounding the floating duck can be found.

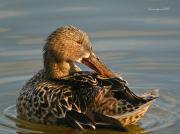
[0,0,180,134]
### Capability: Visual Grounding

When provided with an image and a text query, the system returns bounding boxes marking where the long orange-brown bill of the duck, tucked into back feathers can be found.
[82,54,116,78]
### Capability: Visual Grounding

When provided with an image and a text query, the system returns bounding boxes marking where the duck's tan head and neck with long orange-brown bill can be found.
[44,26,115,79]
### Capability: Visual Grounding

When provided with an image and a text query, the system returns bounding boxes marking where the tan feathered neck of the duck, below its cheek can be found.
[44,61,80,79]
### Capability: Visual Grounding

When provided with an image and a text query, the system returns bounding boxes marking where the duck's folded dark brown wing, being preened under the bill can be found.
[57,72,154,131]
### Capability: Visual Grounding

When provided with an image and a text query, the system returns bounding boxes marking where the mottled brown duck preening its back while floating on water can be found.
[16,26,157,131]
